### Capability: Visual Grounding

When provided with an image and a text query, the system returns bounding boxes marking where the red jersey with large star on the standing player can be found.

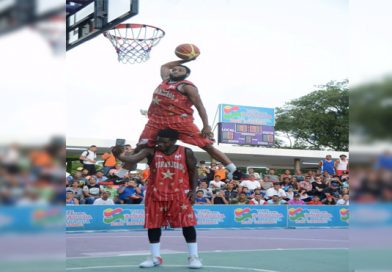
[147,146,189,201]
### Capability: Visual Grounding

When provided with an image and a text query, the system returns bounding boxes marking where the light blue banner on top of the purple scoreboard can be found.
[219,104,275,127]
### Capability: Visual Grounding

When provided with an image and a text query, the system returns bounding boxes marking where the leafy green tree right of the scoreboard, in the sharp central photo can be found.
[275,80,349,151]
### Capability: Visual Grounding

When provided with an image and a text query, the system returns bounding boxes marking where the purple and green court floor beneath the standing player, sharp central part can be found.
[66,229,349,272]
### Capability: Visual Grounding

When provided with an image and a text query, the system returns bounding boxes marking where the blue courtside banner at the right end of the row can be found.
[287,205,350,227]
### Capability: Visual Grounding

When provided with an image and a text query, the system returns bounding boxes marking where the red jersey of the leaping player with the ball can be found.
[148,80,195,123]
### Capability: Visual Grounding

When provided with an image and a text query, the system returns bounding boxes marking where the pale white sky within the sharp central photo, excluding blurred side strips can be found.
[66,0,348,144]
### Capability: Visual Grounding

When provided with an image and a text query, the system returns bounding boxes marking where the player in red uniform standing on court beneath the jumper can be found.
[113,129,202,268]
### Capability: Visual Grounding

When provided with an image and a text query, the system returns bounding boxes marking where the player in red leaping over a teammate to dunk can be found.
[137,58,236,179]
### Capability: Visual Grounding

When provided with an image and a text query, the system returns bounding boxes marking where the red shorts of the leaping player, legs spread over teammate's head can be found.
[139,120,214,147]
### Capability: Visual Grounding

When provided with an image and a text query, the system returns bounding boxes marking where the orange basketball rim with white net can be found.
[103,24,165,64]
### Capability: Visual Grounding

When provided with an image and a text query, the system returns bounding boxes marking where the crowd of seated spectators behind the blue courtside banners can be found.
[66,146,349,205]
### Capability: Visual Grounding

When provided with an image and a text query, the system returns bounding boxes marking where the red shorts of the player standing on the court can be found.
[144,198,197,229]
